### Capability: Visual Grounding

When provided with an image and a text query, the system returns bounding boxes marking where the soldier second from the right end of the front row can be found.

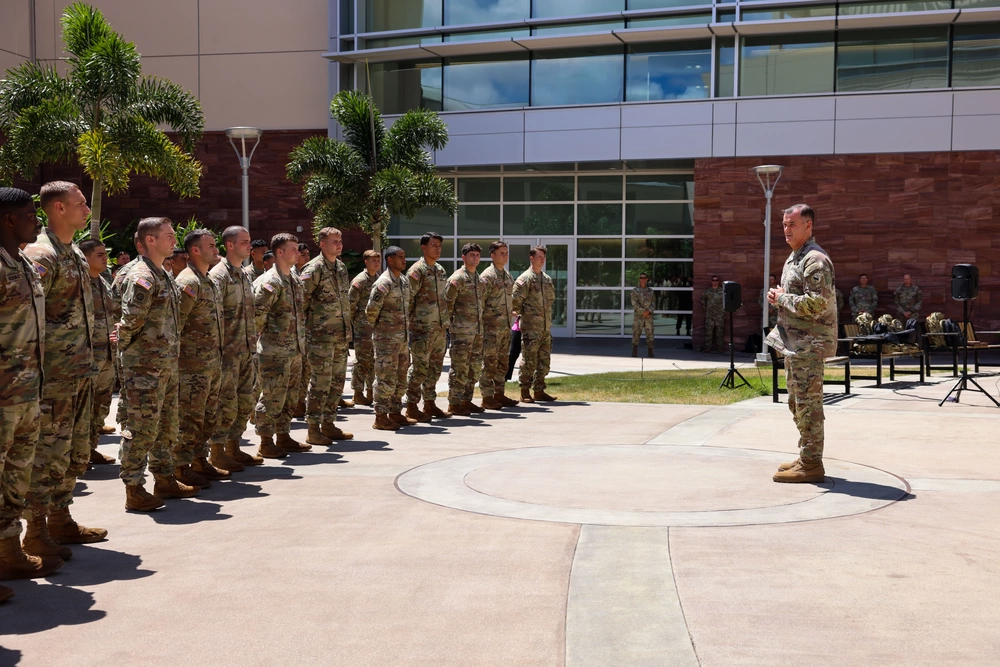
[479,241,517,410]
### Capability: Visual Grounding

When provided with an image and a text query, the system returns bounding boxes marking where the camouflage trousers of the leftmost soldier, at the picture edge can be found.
[0,401,42,538]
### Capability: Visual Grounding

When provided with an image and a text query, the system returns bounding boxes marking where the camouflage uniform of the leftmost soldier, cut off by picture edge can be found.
[0,248,45,538]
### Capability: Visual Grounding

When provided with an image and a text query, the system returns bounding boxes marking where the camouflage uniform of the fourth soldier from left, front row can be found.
[173,263,222,467]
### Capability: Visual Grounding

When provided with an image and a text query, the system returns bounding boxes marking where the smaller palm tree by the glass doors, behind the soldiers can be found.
[288,90,458,253]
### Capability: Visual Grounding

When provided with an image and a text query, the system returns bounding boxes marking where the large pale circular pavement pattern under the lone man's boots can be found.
[396,445,909,526]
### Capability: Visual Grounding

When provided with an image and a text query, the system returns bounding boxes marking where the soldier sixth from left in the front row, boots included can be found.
[253,234,312,459]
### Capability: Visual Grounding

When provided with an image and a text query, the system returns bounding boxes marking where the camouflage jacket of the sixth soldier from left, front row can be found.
[253,266,306,357]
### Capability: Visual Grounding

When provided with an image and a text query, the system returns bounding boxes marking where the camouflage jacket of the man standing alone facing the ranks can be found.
[767,237,837,358]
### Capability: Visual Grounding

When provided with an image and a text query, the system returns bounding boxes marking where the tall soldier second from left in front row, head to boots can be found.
[24,181,108,560]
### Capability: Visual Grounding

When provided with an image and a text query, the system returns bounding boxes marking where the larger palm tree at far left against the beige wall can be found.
[0,2,205,238]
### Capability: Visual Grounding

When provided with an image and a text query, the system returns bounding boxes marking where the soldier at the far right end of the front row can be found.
[511,246,556,403]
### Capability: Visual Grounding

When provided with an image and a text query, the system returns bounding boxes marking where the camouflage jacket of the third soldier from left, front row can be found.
[118,257,181,370]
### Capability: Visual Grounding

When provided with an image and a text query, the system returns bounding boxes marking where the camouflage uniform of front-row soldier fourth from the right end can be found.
[406,258,448,405]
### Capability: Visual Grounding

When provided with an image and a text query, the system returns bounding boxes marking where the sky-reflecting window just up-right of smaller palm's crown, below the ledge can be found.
[444,56,530,111]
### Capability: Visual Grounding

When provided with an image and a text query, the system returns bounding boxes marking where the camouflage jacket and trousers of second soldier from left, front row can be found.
[24,227,97,518]
